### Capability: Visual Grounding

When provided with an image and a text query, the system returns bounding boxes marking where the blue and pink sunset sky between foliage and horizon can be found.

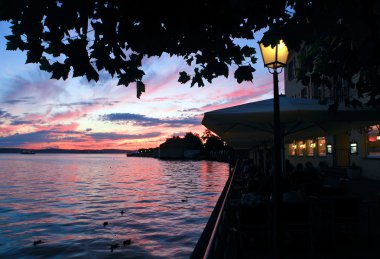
[0,22,283,150]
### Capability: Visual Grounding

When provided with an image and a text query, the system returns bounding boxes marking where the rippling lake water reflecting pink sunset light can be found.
[0,154,228,258]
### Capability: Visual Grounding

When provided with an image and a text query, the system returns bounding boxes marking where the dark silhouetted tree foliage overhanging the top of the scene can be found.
[0,0,380,104]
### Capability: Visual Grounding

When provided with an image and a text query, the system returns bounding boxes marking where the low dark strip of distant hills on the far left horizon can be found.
[0,148,132,154]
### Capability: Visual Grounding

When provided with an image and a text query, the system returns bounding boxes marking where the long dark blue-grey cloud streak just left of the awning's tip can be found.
[101,113,200,127]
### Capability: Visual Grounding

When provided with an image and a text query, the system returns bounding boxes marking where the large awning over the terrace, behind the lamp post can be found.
[202,96,380,149]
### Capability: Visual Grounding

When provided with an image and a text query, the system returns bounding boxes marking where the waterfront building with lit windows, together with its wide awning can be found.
[202,47,380,180]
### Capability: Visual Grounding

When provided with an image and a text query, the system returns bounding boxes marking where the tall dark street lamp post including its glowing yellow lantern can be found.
[260,40,288,258]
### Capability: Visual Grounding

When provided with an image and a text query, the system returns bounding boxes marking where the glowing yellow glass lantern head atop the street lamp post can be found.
[260,40,289,69]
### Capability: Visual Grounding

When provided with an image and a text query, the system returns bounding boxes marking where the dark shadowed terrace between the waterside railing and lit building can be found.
[193,161,380,259]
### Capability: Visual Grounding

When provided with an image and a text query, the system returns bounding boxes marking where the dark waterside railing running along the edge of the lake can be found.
[190,161,239,259]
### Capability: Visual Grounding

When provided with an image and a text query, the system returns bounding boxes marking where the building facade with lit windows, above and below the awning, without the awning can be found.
[284,52,380,180]
